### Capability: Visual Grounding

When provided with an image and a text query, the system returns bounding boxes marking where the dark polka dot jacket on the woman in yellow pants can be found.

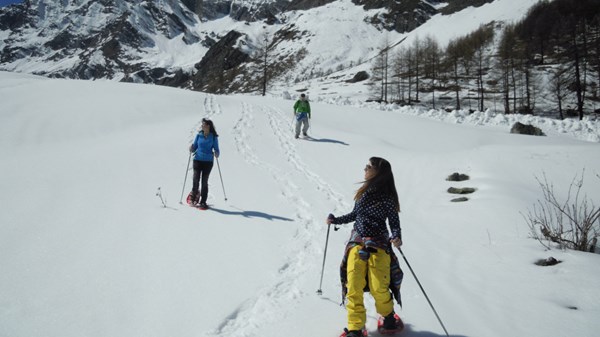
[332,186,402,241]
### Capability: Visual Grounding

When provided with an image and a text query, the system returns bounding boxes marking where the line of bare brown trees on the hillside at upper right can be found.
[371,0,600,119]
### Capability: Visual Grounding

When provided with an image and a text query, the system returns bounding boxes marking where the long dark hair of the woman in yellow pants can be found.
[354,157,400,212]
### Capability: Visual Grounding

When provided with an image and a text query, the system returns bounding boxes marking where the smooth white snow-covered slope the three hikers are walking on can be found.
[0,72,600,337]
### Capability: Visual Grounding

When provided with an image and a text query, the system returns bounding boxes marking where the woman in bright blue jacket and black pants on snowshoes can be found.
[188,118,220,209]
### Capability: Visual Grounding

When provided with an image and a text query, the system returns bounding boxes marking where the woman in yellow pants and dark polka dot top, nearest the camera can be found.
[327,157,402,337]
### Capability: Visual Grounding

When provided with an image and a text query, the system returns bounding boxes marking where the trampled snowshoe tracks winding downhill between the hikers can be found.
[210,102,350,337]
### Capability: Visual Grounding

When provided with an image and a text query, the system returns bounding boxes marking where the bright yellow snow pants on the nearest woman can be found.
[346,246,394,330]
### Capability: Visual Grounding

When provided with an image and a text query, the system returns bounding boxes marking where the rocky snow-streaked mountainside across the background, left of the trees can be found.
[0,0,491,92]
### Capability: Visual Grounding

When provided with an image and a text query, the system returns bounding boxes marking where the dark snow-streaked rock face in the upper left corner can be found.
[0,0,203,83]
